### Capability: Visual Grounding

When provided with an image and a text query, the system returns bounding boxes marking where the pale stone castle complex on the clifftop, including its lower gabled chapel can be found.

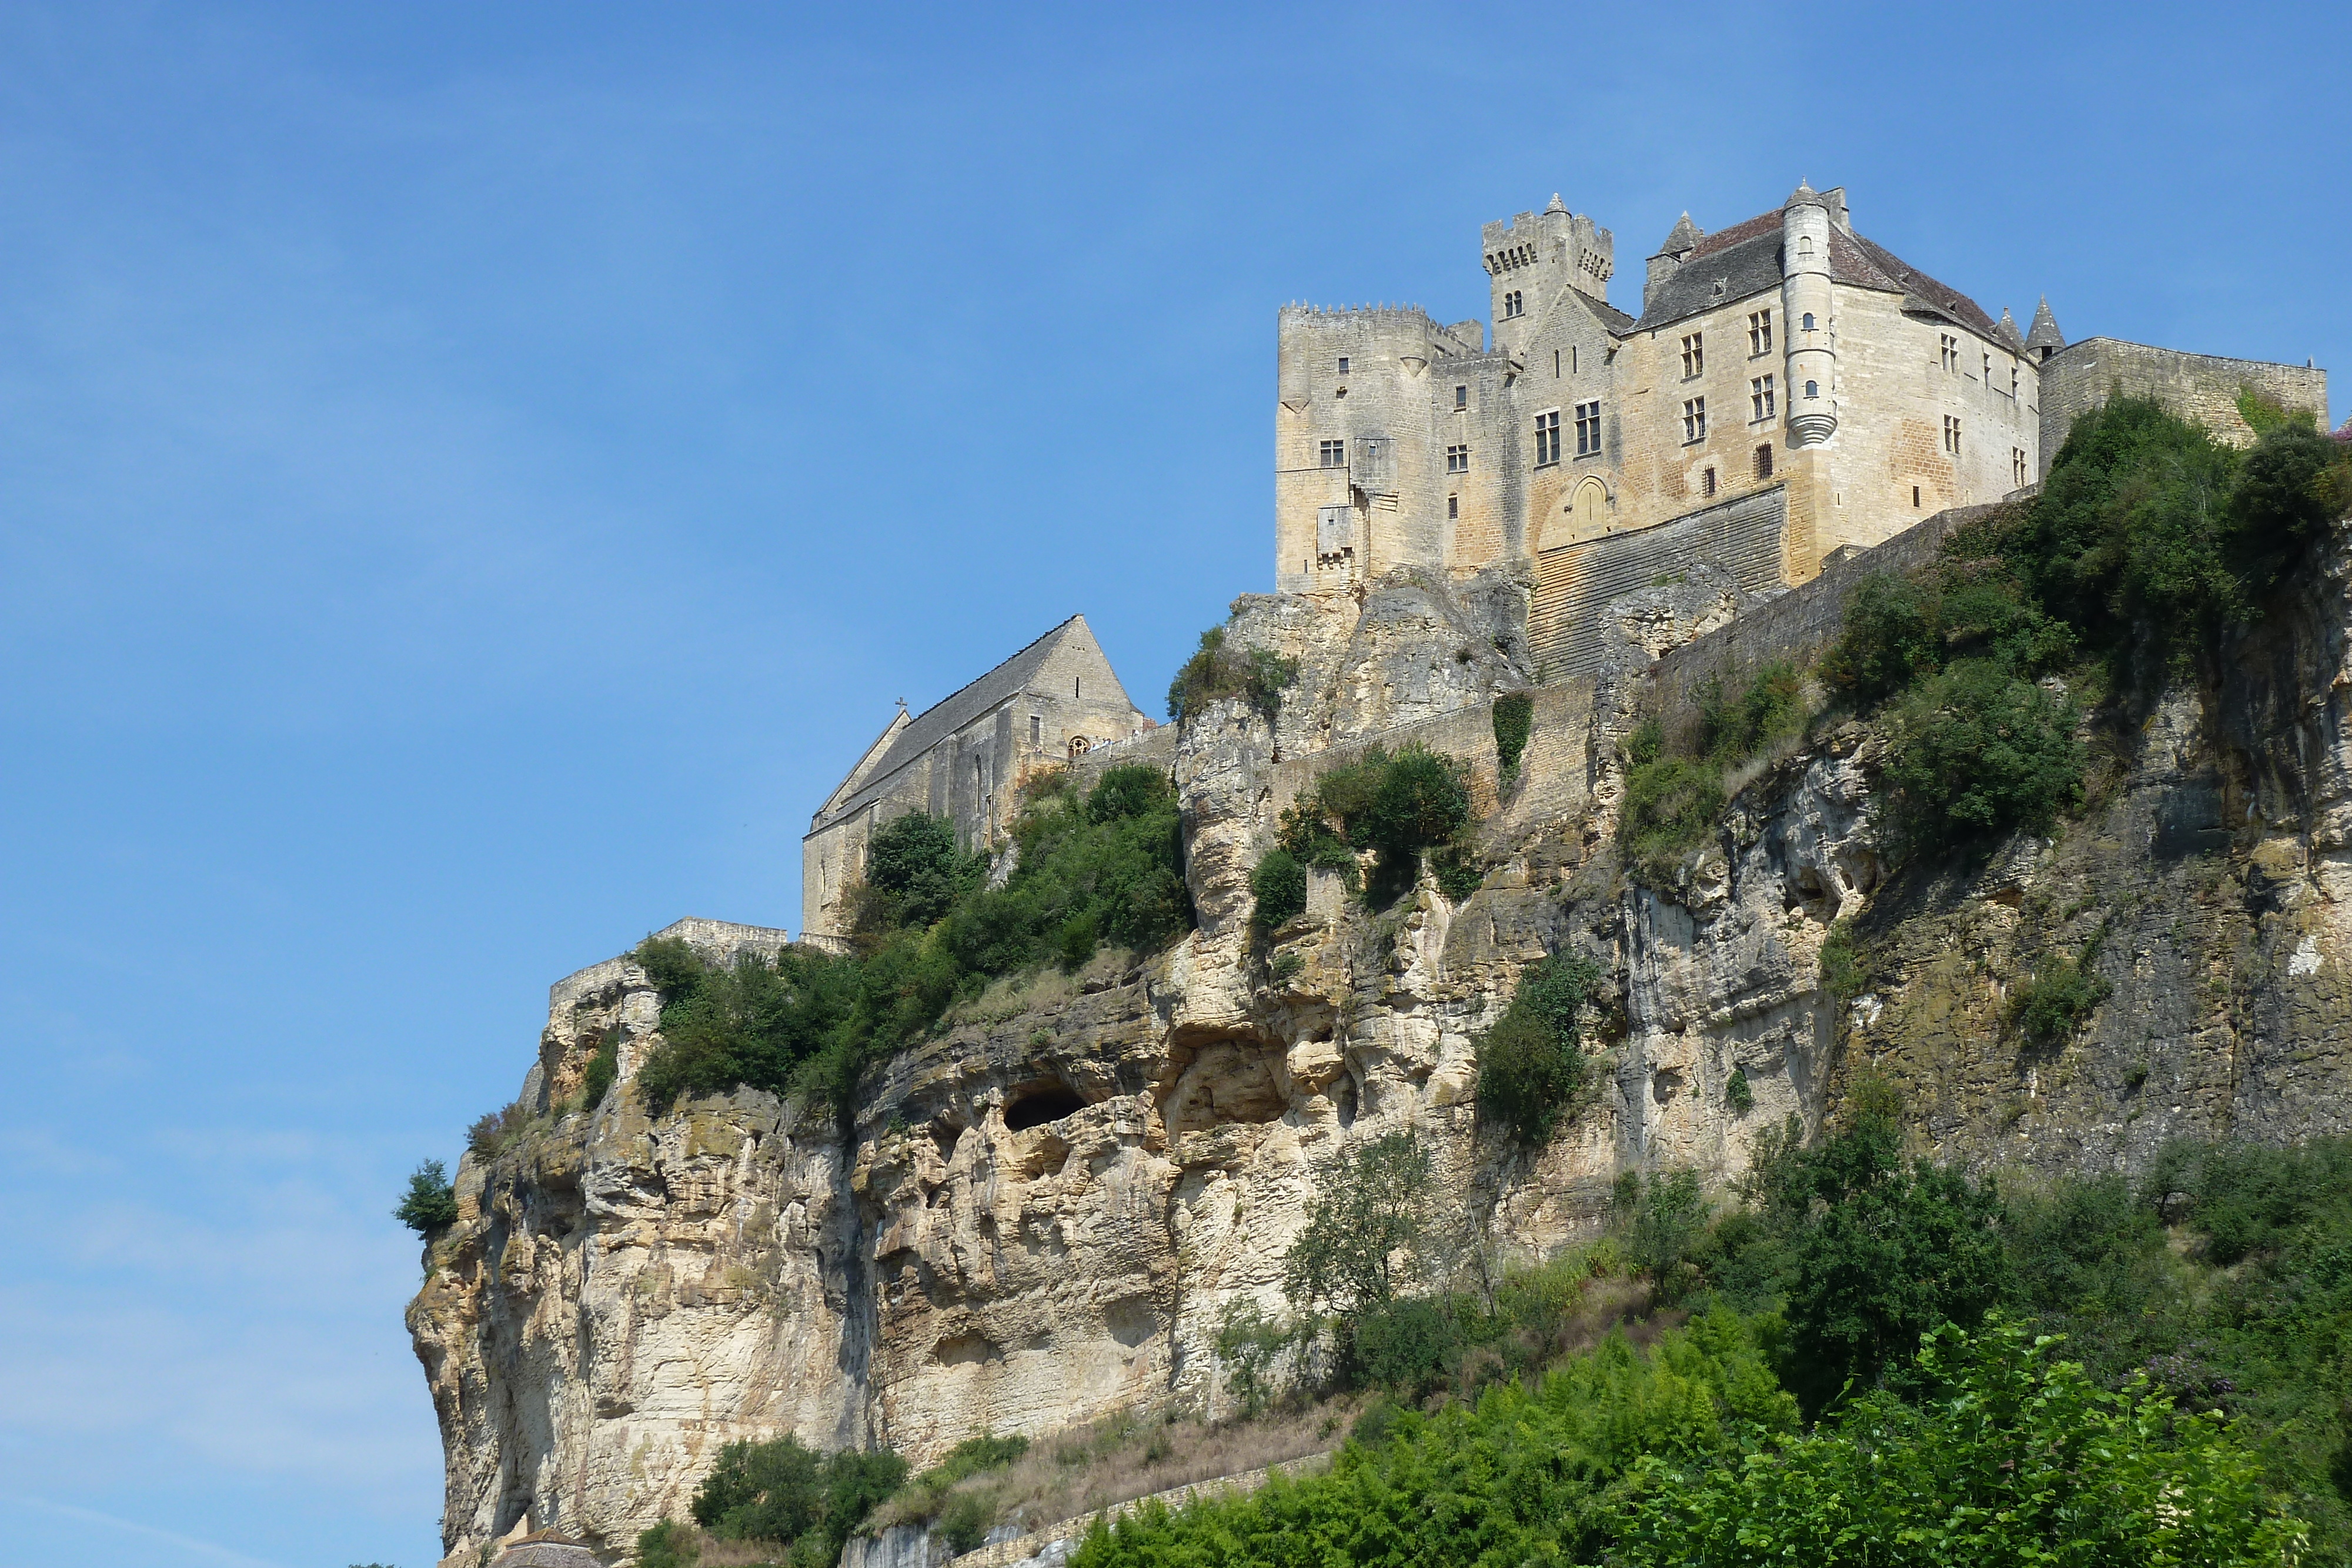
[802,183,2328,945]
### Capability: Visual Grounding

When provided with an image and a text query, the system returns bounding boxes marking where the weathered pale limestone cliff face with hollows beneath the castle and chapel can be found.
[409,524,2352,1561]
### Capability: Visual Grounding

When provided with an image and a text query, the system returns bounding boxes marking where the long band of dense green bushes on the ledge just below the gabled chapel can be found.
[635,767,1192,1109]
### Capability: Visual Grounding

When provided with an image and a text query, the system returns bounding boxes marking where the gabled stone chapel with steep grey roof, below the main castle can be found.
[800,616,1152,945]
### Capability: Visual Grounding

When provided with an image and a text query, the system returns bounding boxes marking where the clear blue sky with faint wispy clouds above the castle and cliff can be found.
[0,0,2352,1568]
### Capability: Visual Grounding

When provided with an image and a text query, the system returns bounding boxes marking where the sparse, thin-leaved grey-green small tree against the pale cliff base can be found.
[1282,1133,1430,1314]
